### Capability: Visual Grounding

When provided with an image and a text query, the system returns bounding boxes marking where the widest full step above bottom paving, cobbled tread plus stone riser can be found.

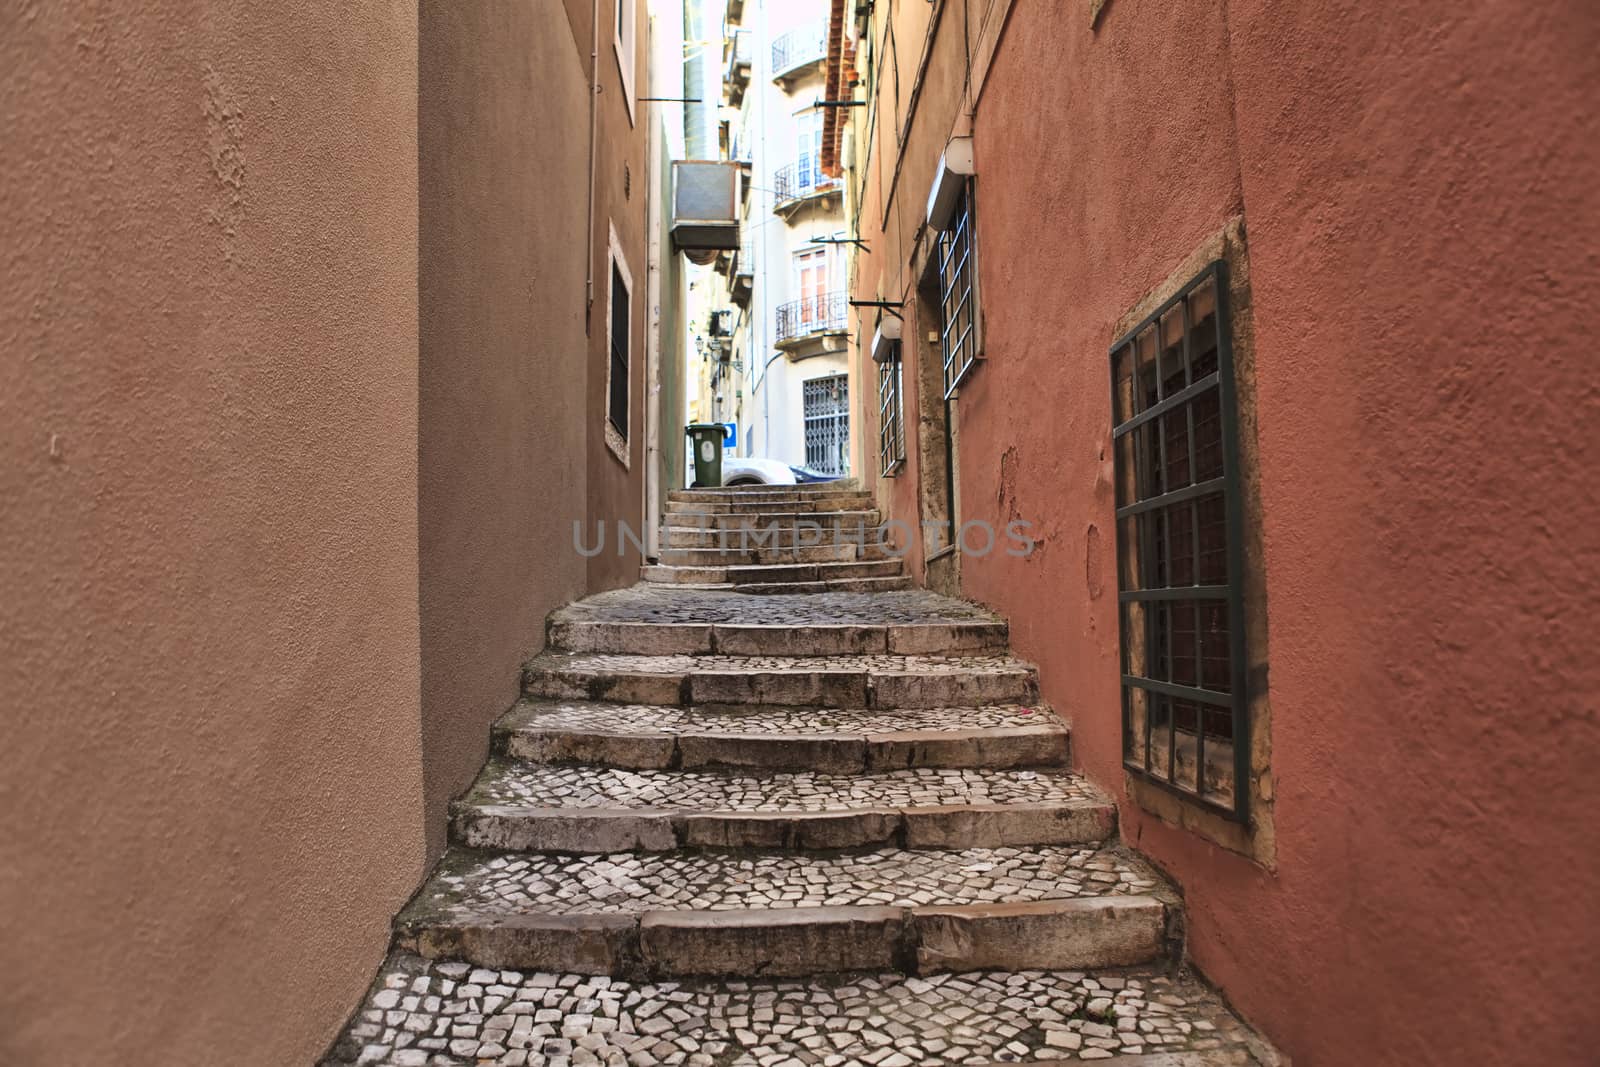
[395,846,1181,977]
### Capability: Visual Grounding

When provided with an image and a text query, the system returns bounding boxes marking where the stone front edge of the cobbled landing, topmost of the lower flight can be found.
[546,607,1008,656]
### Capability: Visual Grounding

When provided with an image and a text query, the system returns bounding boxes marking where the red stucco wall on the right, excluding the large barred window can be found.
[962,0,1600,1067]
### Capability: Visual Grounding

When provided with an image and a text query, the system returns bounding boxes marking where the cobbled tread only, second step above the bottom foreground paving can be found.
[466,760,1102,813]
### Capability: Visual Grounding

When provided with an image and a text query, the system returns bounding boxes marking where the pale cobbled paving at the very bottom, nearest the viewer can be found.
[325,952,1259,1067]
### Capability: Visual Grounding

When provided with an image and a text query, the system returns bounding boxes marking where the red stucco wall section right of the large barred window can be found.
[1197,0,1600,1064]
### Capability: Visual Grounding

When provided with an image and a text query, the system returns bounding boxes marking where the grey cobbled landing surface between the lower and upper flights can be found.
[554,582,1000,625]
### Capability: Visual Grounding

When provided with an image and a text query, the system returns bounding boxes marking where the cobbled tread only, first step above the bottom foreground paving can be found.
[408,845,1160,917]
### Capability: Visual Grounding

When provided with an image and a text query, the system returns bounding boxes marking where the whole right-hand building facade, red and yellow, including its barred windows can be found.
[822,0,1600,1064]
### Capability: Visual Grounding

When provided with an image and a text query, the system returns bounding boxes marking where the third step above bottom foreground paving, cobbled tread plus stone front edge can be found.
[494,701,1070,774]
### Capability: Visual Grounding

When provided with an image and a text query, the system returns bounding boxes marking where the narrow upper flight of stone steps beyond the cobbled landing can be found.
[642,480,910,593]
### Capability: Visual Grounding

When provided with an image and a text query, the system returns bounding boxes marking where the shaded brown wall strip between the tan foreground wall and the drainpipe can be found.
[418,0,589,853]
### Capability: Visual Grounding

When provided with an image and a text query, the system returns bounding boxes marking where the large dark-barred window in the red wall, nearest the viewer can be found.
[1110,261,1250,821]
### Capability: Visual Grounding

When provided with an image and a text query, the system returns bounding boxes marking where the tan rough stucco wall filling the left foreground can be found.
[0,0,422,1067]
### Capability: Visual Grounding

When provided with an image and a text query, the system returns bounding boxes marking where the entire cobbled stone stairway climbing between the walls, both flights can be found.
[331,483,1258,1067]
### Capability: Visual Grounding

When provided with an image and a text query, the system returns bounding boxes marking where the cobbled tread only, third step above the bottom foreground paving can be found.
[502,701,1061,736]
